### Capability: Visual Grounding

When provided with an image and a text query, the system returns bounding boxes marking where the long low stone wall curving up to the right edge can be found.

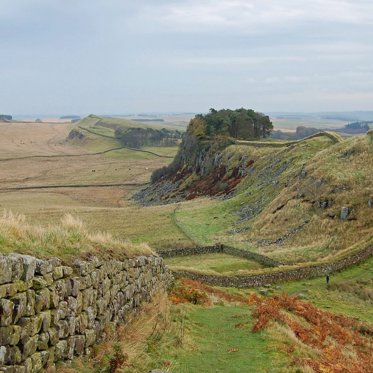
[173,246,373,288]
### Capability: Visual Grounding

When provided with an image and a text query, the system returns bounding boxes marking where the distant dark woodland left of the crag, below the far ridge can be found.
[115,127,182,148]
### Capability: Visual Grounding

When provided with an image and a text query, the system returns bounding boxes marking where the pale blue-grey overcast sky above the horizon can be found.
[0,0,373,115]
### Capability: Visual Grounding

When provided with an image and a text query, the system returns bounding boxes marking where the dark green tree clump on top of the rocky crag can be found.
[188,108,273,140]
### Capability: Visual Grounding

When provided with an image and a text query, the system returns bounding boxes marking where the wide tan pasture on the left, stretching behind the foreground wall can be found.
[0,123,191,247]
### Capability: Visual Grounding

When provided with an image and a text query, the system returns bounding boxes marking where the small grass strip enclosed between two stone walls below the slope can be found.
[165,253,262,274]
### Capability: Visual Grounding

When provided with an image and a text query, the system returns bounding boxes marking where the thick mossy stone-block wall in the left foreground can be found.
[0,254,172,373]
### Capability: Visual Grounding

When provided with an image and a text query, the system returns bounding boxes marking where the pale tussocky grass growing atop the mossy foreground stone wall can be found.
[0,210,152,262]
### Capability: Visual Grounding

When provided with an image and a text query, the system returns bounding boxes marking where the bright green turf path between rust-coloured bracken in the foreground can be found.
[163,306,286,373]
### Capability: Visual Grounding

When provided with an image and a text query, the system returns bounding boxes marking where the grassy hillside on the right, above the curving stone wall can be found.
[176,137,373,264]
